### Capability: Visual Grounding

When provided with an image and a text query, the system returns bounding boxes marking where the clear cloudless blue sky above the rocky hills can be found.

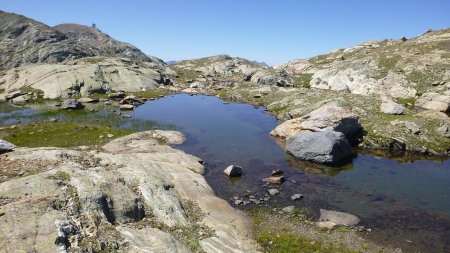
[0,0,450,65]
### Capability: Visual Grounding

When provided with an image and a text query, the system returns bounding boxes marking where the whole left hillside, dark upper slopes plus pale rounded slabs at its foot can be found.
[0,12,175,99]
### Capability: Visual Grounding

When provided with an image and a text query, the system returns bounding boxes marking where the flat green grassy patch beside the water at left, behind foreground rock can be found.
[4,122,133,147]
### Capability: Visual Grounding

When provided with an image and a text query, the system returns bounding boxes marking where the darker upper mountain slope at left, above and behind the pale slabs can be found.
[0,12,160,68]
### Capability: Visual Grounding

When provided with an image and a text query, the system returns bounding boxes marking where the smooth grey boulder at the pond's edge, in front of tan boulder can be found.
[286,131,352,164]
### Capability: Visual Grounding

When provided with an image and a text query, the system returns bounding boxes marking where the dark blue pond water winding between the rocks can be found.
[0,94,450,252]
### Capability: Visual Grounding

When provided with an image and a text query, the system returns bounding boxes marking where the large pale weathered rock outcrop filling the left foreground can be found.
[0,130,256,252]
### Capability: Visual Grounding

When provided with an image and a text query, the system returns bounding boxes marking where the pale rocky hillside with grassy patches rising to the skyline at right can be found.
[275,29,450,111]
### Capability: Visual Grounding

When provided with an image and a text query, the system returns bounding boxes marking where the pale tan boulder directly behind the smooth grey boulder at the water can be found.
[270,103,362,139]
